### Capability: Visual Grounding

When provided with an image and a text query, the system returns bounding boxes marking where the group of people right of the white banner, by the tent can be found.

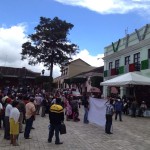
[105,96,147,134]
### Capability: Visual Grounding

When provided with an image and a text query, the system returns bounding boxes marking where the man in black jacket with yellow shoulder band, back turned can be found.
[48,98,64,144]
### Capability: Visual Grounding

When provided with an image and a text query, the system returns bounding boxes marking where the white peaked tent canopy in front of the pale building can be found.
[100,72,150,86]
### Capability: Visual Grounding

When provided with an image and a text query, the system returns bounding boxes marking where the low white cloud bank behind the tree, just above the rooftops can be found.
[0,24,103,77]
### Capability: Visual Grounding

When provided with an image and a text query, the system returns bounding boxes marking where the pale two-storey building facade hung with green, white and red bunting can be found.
[103,24,150,97]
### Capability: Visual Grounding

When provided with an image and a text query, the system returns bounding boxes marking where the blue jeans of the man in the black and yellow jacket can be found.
[48,124,61,143]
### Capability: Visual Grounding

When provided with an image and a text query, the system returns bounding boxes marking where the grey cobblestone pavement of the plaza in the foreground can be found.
[0,105,150,150]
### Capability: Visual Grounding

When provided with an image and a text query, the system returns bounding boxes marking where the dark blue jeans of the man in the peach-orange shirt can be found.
[24,116,34,138]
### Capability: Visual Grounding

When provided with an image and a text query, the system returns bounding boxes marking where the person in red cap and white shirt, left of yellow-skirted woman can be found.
[4,98,12,140]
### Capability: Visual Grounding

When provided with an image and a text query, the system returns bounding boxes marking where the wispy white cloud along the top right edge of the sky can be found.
[55,0,150,14]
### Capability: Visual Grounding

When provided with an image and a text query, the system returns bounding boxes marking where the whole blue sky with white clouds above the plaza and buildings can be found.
[0,0,150,77]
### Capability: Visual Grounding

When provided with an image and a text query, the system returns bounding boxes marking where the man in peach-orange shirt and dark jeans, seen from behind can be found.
[24,97,36,139]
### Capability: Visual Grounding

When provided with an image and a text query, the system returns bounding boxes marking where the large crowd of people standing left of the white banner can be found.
[0,87,89,146]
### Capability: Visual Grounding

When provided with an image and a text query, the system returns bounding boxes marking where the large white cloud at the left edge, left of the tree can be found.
[0,25,27,65]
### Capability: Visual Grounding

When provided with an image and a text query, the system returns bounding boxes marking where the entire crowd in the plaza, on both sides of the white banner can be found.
[0,87,147,146]
